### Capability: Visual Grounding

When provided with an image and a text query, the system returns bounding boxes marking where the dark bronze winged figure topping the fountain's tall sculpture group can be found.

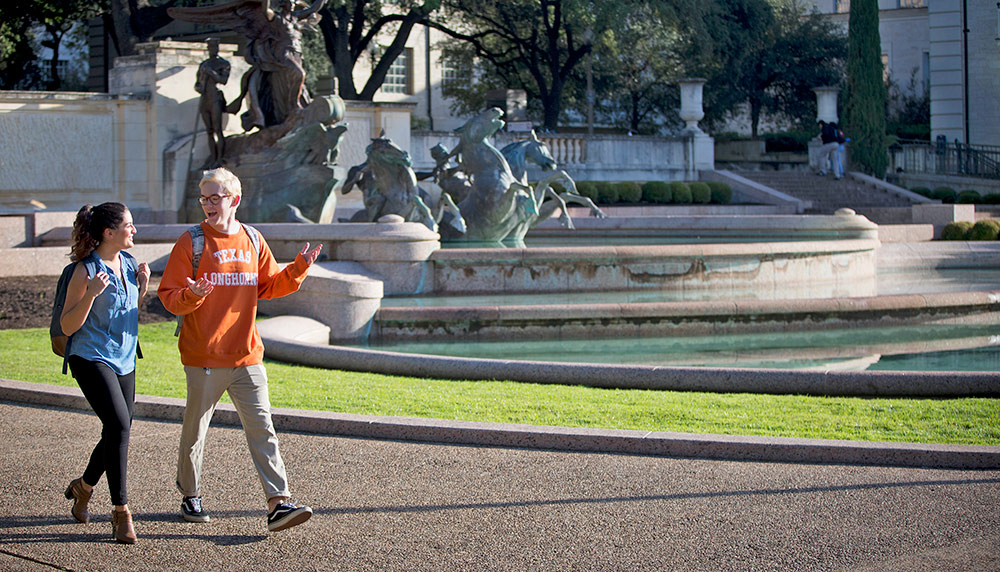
[168,0,325,131]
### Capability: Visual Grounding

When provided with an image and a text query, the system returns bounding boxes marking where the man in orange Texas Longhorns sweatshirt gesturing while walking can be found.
[157,168,322,532]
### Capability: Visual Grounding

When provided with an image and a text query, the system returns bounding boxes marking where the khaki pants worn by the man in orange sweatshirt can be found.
[177,365,291,499]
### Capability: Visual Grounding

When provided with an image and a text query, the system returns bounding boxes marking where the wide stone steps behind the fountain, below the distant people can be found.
[738,171,913,219]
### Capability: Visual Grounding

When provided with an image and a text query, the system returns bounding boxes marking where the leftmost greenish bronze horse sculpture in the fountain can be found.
[341,133,465,234]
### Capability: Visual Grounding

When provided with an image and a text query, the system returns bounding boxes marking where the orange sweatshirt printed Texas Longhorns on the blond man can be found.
[156,223,309,368]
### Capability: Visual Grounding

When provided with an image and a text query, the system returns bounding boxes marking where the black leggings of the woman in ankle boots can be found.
[69,356,135,505]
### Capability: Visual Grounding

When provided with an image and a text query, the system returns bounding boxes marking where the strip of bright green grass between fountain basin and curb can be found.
[0,322,1000,445]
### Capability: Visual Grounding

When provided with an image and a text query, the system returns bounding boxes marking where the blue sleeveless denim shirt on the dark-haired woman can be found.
[69,252,139,375]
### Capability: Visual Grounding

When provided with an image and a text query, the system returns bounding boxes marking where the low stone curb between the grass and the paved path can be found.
[0,379,1000,469]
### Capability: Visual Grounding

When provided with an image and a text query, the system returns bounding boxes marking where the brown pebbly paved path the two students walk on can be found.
[0,402,1000,572]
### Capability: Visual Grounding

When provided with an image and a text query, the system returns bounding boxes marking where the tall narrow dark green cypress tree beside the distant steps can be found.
[846,0,889,179]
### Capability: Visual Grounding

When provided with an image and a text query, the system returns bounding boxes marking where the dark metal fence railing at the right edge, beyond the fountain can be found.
[889,137,1000,179]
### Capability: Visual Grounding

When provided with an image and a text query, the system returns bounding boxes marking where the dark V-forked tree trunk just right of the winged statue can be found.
[319,0,440,101]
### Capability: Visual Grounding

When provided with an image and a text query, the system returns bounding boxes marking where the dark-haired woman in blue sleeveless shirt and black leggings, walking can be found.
[60,203,149,544]
